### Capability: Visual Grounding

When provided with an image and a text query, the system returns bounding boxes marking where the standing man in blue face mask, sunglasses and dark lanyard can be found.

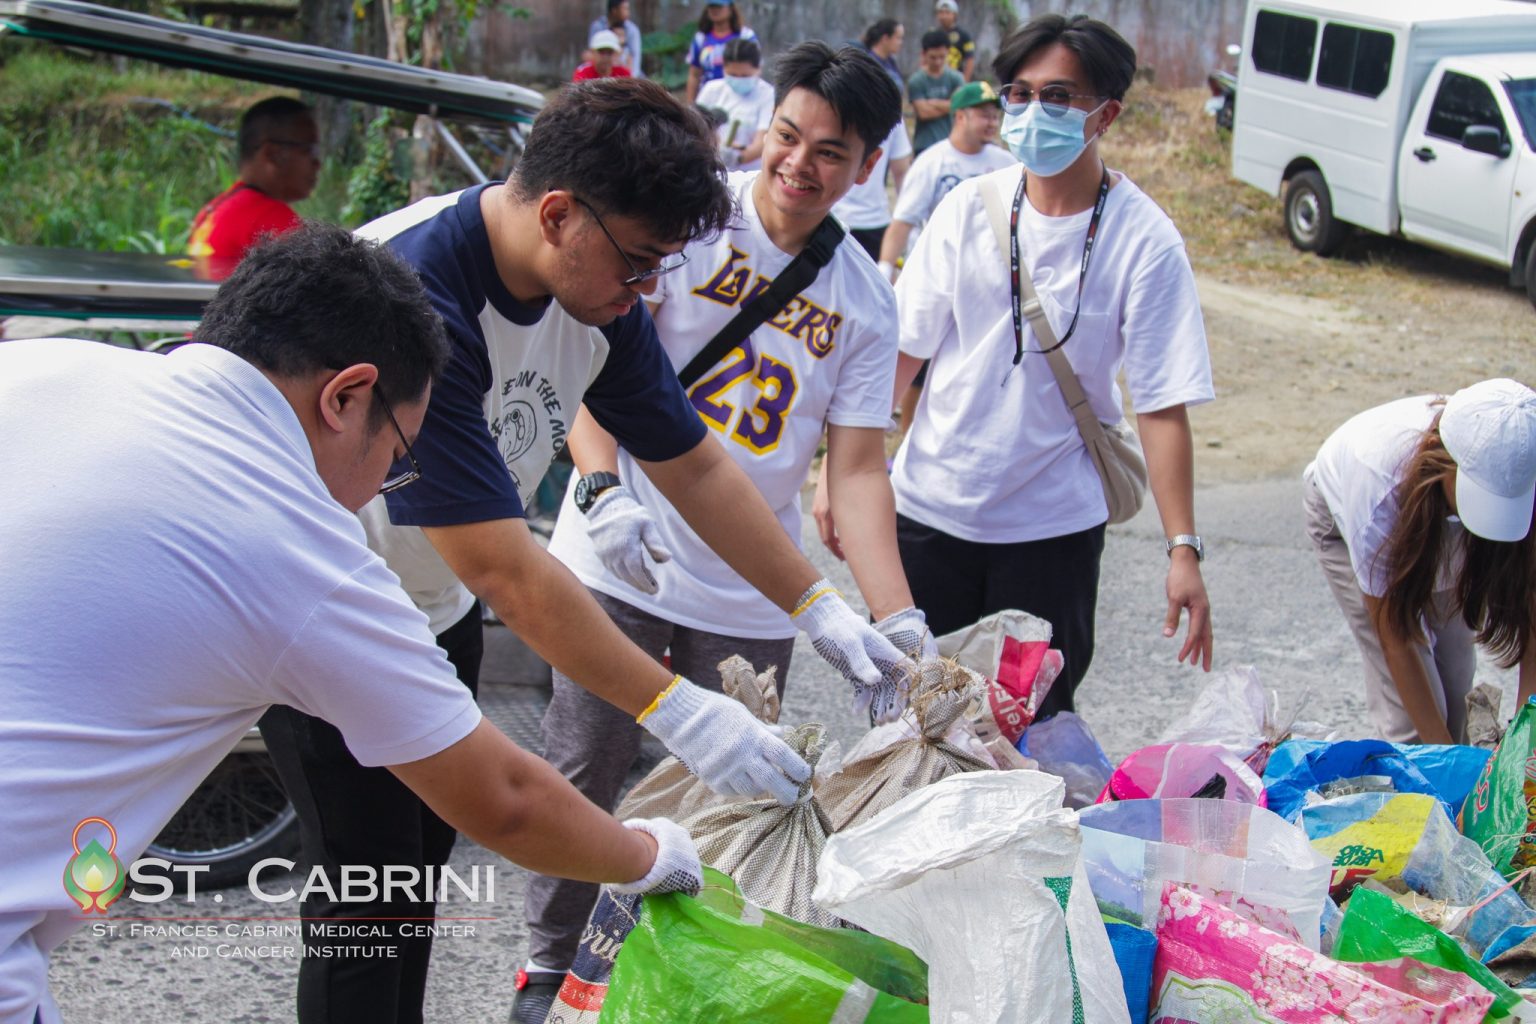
[820,14,1213,715]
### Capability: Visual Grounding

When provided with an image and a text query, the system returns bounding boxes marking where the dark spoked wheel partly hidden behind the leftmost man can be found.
[144,749,298,889]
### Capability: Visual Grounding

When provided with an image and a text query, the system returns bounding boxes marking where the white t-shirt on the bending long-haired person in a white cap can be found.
[1303,395,1462,597]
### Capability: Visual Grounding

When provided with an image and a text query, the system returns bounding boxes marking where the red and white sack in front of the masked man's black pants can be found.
[938,611,1061,752]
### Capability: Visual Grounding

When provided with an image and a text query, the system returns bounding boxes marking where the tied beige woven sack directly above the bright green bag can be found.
[679,723,842,927]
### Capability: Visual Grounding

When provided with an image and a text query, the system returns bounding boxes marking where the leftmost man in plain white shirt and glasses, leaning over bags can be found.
[0,226,700,1024]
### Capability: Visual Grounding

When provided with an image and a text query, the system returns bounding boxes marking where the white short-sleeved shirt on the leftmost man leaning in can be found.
[0,339,481,1022]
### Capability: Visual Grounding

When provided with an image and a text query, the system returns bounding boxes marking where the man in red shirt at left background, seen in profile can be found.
[187,97,319,270]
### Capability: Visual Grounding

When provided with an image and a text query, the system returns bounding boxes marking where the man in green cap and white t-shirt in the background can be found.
[879,81,1018,269]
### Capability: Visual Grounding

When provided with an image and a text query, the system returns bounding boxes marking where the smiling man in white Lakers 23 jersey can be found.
[527,43,932,1007]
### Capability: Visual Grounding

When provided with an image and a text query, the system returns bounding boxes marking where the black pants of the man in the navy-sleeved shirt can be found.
[261,602,485,1024]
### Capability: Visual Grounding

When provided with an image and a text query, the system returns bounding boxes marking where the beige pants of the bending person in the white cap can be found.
[1301,479,1478,743]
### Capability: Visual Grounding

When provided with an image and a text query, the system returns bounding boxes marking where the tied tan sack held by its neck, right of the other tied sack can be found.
[814,659,997,832]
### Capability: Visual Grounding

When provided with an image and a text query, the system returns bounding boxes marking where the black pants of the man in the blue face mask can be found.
[895,516,1104,718]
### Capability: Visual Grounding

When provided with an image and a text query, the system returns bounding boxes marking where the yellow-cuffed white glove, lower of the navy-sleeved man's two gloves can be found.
[636,676,811,808]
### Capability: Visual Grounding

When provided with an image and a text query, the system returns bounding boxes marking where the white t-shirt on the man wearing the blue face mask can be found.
[891,167,1213,543]
